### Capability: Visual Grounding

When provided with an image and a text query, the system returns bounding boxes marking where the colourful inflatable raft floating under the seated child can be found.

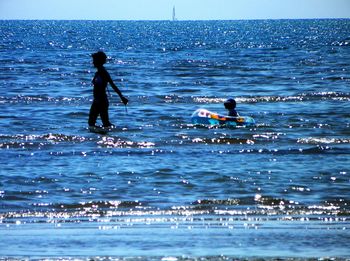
[191,109,255,127]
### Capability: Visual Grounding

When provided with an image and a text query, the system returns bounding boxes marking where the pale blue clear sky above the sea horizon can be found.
[0,0,350,20]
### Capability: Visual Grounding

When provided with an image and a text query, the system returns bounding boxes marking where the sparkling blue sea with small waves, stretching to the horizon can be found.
[0,19,350,261]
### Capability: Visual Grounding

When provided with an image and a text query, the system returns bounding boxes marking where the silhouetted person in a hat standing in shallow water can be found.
[89,51,128,127]
